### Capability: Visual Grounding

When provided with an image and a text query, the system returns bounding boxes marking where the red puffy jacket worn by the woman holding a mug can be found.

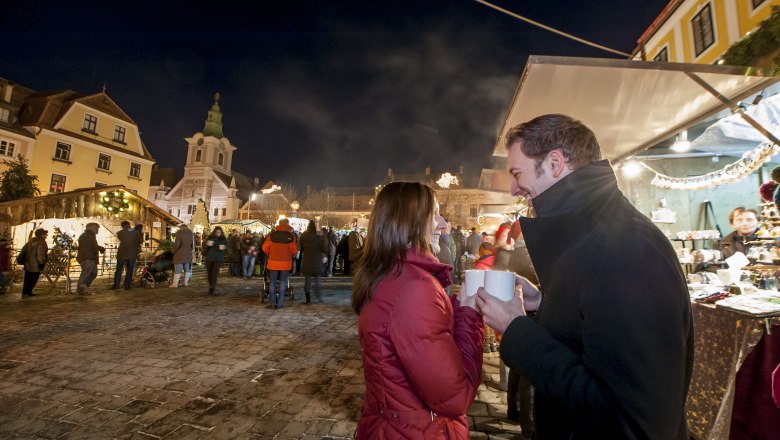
[357,250,484,440]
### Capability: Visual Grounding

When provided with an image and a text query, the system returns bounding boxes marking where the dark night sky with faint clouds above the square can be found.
[0,0,668,188]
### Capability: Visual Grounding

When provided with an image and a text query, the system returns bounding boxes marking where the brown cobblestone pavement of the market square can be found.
[0,271,520,439]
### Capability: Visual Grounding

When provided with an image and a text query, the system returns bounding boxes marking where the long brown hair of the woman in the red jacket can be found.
[352,182,435,314]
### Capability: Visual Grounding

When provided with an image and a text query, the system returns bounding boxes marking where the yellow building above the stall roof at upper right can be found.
[634,0,780,64]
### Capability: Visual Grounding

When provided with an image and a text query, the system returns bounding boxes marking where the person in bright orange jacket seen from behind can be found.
[263,218,298,309]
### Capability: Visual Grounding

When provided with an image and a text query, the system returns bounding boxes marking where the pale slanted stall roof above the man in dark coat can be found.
[493,56,780,163]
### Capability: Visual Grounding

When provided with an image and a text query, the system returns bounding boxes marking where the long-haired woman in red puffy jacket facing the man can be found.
[352,182,483,440]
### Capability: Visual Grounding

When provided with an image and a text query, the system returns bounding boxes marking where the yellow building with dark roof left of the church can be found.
[0,80,154,197]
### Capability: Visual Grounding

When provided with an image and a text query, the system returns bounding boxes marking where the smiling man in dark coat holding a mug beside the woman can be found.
[477,115,693,440]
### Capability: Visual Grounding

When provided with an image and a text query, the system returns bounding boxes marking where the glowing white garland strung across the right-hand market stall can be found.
[640,141,780,190]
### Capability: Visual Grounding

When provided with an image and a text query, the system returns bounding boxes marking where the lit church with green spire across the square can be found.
[148,93,259,224]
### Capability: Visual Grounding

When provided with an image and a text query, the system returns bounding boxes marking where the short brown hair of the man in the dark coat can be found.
[505,114,601,173]
